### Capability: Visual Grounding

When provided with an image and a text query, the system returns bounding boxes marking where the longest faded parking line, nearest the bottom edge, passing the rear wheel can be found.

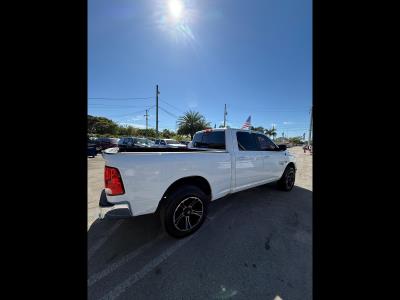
[97,203,233,300]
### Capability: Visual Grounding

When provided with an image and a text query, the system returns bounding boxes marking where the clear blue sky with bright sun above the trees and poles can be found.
[88,0,312,137]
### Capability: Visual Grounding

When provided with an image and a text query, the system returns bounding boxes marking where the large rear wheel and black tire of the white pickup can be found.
[160,185,209,238]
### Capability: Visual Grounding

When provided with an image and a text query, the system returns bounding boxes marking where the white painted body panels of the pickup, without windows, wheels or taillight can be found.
[103,129,296,216]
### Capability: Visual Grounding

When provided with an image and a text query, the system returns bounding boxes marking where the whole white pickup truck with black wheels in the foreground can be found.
[99,129,296,237]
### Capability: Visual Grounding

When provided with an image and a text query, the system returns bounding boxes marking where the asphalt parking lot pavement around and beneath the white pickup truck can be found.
[88,147,312,300]
